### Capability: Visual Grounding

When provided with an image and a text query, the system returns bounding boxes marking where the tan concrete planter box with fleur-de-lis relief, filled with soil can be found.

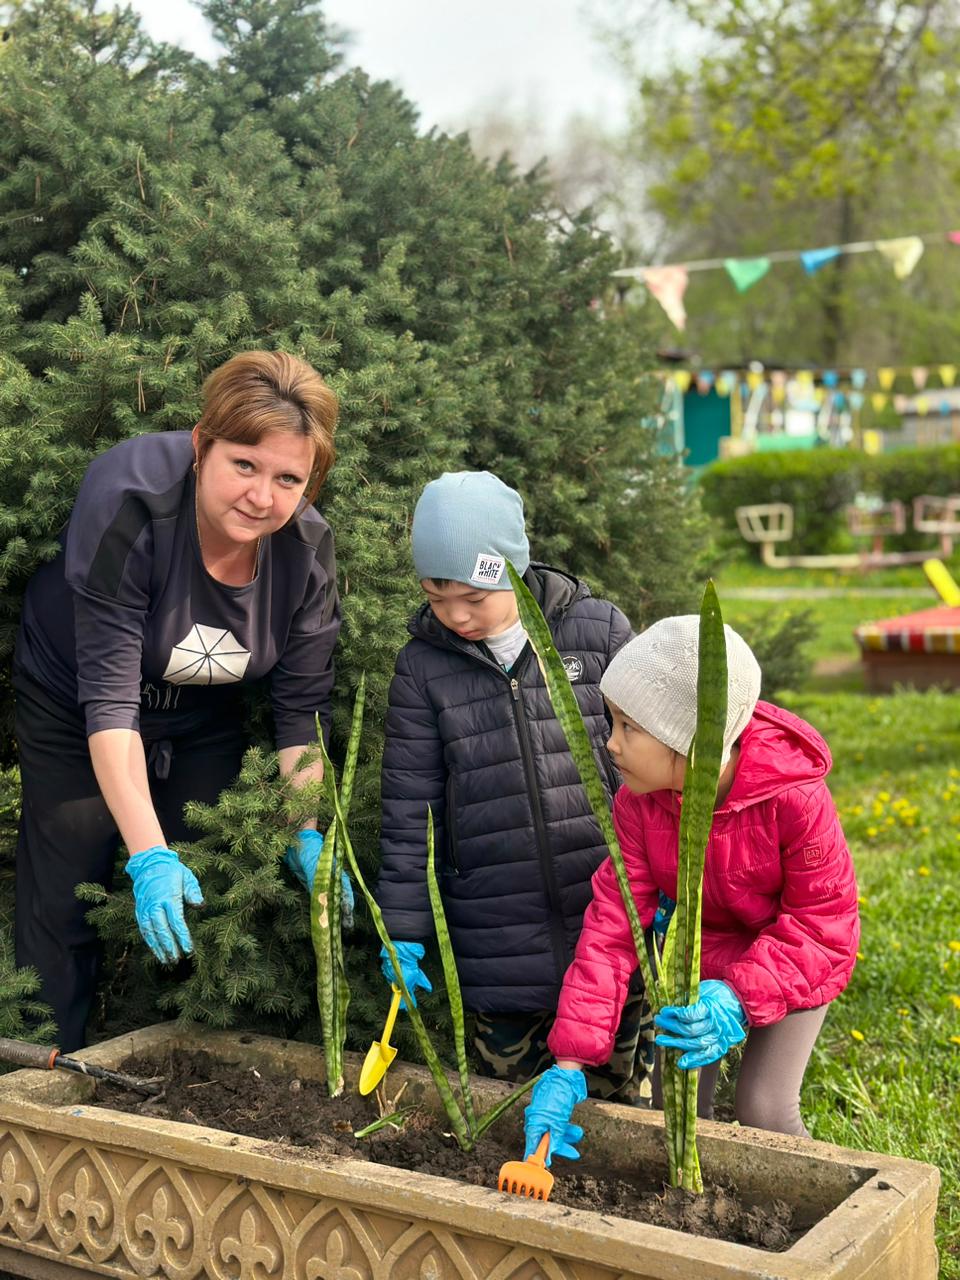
[0,1024,940,1280]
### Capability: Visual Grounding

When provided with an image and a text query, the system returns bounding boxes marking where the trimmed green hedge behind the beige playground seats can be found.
[700,444,960,556]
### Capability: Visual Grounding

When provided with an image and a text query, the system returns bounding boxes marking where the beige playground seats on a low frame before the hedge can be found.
[735,494,960,570]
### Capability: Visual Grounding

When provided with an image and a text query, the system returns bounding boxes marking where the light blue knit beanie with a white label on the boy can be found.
[413,471,530,591]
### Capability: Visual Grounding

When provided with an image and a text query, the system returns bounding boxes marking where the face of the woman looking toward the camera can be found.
[193,429,314,545]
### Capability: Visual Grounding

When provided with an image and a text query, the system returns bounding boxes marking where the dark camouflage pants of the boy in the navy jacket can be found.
[474,992,654,1106]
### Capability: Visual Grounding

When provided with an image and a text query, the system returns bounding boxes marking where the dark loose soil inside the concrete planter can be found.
[96,1050,803,1251]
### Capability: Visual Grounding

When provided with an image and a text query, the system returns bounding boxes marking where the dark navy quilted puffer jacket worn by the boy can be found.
[376,564,631,1012]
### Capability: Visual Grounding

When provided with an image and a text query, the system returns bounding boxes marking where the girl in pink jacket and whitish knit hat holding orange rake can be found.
[525,616,860,1164]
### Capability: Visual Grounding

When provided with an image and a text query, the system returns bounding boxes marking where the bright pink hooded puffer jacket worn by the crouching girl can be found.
[548,703,860,1066]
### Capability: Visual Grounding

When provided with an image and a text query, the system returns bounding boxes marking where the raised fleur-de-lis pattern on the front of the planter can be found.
[0,1123,618,1280]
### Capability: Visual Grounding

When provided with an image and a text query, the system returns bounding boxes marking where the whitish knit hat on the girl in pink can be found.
[600,613,760,768]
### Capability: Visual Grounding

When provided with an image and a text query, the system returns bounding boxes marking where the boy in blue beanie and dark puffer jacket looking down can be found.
[378,471,653,1102]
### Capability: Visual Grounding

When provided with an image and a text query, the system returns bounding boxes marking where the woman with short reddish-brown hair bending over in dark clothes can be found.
[14,351,339,1052]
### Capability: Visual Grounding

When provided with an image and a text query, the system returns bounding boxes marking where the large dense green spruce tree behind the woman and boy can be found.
[0,0,703,1044]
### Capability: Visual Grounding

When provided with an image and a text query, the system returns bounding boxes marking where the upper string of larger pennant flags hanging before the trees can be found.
[613,230,960,332]
